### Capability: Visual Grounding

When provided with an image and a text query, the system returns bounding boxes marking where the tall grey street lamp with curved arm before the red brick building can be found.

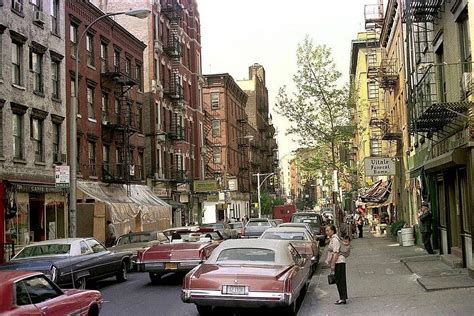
[69,9,151,237]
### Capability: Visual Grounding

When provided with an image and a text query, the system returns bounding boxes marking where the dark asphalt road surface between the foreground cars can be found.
[97,273,312,316]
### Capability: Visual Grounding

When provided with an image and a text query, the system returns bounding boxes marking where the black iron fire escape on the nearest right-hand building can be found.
[406,0,474,141]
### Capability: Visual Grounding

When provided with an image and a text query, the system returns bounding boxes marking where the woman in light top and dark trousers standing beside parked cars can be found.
[326,225,347,305]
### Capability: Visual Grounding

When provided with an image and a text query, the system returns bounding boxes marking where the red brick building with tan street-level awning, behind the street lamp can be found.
[65,1,171,240]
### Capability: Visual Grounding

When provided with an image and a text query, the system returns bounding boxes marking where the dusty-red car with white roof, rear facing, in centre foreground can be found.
[181,239,311,315]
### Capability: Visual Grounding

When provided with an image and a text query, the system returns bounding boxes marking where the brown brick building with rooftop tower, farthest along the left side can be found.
[237,64,278,196]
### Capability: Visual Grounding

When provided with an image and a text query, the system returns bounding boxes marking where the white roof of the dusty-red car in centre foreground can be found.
[206,239,294,265]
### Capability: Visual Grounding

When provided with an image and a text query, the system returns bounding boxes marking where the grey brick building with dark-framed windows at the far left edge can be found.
[0,0,67,254]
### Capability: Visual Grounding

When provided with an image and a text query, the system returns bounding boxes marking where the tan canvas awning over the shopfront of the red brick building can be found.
[77,181,171,224]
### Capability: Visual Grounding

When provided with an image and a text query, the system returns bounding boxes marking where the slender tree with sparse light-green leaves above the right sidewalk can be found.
[276,36,356,198]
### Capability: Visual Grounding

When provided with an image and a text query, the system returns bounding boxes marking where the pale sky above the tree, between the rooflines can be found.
[197,0,377,158]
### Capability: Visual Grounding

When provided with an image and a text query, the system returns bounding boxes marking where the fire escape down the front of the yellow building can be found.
[364,0,386,156]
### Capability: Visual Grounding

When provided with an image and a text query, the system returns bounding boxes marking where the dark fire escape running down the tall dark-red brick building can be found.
[161,0,186,183]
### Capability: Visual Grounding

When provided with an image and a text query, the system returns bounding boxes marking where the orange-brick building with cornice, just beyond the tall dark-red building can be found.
[203,74,252,223]
